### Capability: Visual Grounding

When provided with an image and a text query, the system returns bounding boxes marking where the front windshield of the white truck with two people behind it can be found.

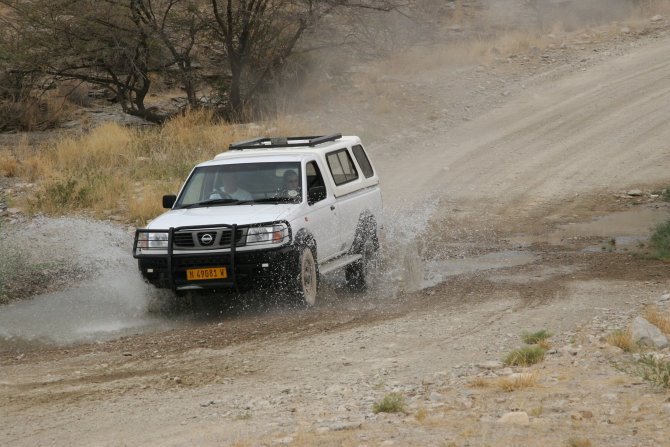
[175,162,302,208]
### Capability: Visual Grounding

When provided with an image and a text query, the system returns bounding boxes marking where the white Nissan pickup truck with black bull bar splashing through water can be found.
[133,135,382,306]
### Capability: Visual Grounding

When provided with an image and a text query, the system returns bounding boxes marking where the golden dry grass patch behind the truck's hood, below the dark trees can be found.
[0,111,295,224]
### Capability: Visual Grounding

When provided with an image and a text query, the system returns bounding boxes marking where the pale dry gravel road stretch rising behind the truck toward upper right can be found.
[381,38,670,216]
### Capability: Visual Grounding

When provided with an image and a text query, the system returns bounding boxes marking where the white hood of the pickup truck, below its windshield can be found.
[147,204,300,230]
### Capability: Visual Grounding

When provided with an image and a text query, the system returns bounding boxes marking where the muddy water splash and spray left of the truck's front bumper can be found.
[0,217,169,345]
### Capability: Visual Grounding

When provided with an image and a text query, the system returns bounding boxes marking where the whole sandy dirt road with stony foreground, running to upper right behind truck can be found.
[0,3,670,446]
